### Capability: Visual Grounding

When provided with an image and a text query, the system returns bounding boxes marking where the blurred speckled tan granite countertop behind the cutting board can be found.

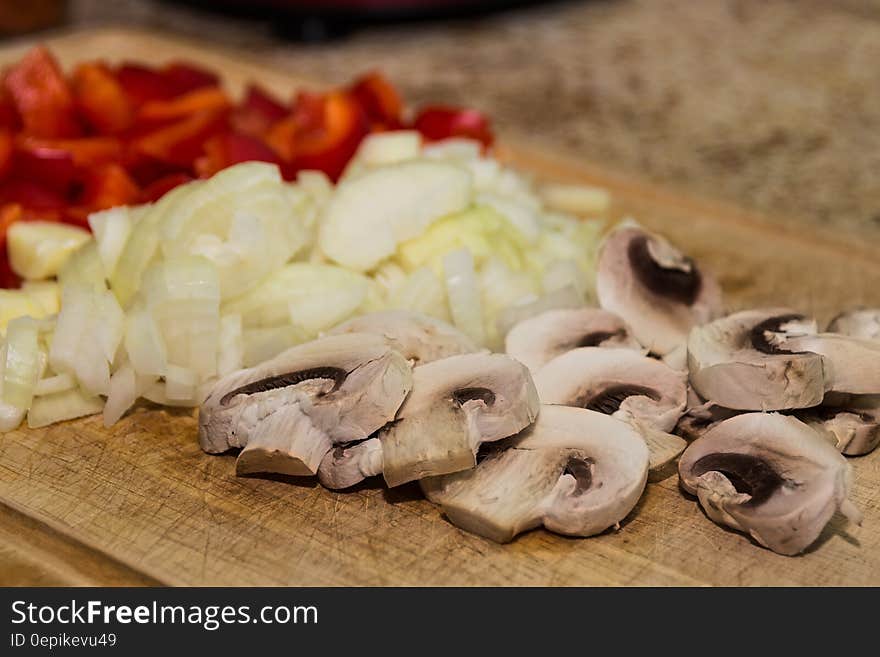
[71,0,880,244]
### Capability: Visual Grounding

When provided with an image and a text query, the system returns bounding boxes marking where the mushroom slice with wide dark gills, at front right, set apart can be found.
[678,413,861,555]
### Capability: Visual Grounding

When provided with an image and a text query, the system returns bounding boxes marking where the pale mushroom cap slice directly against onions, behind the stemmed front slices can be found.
[328,310,480,365]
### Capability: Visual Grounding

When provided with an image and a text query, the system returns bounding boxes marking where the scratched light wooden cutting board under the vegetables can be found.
[0,30,880,586]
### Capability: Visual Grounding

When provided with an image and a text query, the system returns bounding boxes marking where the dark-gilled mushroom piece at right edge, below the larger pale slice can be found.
[798,393,880,456]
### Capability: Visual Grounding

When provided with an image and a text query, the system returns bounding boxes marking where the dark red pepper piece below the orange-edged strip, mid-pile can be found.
[132,112,227,170]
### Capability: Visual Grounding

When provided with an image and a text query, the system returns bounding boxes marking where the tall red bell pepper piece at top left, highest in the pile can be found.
[4,46,81,138]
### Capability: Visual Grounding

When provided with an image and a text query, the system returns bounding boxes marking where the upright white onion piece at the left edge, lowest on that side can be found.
[2,317,43,410]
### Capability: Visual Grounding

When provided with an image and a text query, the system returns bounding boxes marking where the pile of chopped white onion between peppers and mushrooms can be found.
[0,125,608,430]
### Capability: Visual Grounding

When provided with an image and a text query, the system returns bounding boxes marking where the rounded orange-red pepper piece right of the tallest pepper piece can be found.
[72,63,134,135]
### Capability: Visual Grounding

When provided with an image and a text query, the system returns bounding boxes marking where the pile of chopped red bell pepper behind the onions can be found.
[0,47,492,287]
